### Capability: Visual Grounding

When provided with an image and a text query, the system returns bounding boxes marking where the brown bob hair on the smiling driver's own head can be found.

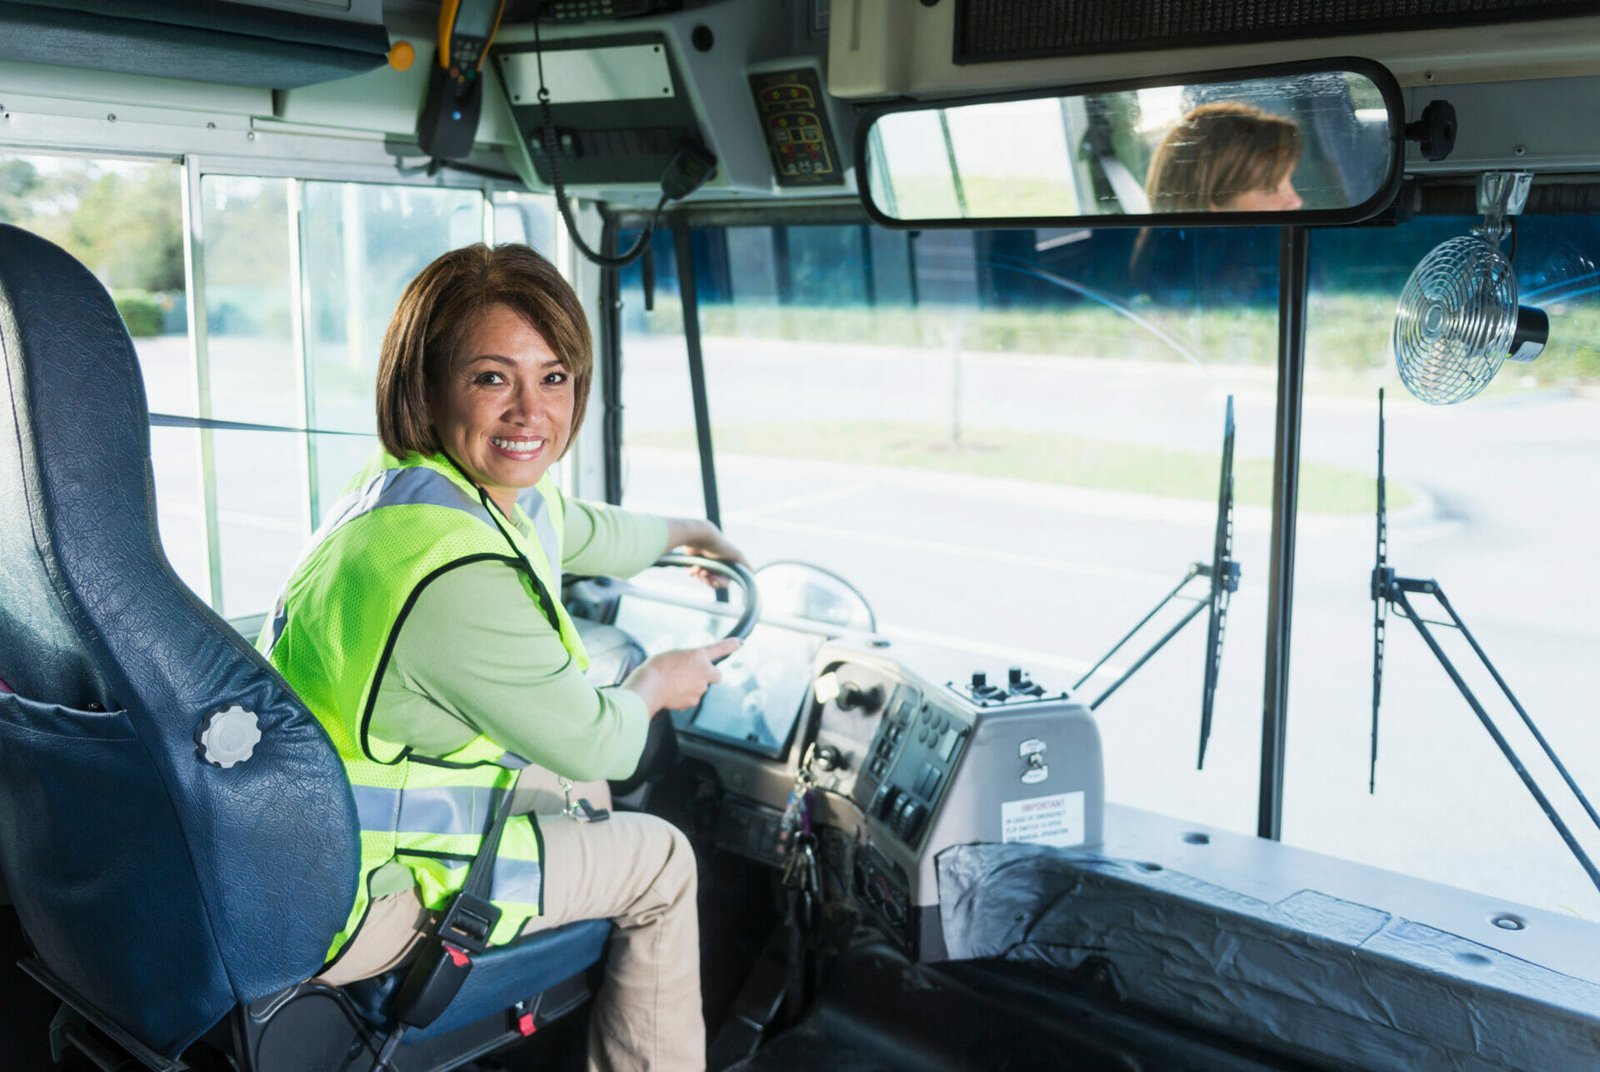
[378,242,594,458]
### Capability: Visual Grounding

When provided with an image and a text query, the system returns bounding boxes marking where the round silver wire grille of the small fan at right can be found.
[1394,235,1517,406]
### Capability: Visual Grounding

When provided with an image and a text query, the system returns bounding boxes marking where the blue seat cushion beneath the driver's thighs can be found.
[346,920,611,1042]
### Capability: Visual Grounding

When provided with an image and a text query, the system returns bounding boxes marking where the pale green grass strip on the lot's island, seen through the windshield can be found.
[629,422,1416,514]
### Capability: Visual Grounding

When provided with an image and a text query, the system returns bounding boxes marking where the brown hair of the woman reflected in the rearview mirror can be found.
[1144,101,1301,213]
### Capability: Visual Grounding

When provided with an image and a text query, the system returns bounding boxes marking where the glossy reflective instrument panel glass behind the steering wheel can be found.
[614,595,822,758]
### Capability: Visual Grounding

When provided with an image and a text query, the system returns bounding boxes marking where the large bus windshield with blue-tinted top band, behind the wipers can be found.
[624,218,1600,915]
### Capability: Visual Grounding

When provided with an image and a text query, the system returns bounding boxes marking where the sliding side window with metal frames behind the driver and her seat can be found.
[0,155,499,619]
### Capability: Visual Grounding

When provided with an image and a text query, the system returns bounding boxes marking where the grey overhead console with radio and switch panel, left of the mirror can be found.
[485,0,858,201]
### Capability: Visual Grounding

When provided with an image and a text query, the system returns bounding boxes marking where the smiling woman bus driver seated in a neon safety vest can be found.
[262,245,742,1070]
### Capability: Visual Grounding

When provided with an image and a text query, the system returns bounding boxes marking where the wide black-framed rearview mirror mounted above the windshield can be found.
[856,59,1405,227]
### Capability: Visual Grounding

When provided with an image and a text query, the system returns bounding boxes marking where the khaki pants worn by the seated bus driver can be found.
[322,813,706,1072]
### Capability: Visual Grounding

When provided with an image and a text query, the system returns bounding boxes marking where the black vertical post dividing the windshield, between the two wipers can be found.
[1256,227,1310,840]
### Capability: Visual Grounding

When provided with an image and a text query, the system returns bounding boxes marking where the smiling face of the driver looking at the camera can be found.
[427,306,573,515]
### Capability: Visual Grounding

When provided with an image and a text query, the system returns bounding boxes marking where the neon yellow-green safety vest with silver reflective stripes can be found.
[259,453,587,957]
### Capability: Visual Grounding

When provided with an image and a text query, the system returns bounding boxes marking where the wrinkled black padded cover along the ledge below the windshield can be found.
[938,851,1600,1072]
